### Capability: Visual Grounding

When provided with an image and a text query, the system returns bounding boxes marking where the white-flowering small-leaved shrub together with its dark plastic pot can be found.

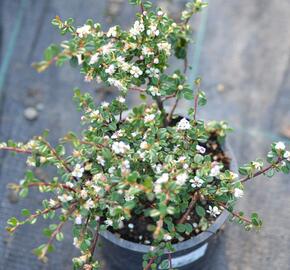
[0,0,290,270]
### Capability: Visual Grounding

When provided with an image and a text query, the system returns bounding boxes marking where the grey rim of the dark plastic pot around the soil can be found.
[100,143,238,253]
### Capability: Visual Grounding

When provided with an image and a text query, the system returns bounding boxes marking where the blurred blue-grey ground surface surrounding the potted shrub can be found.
[0,0,290,270]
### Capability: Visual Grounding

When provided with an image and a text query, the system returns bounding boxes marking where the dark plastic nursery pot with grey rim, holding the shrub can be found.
[101,144,237,270]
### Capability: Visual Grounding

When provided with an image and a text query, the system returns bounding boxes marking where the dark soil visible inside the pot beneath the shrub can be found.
[108,134,230,245]
